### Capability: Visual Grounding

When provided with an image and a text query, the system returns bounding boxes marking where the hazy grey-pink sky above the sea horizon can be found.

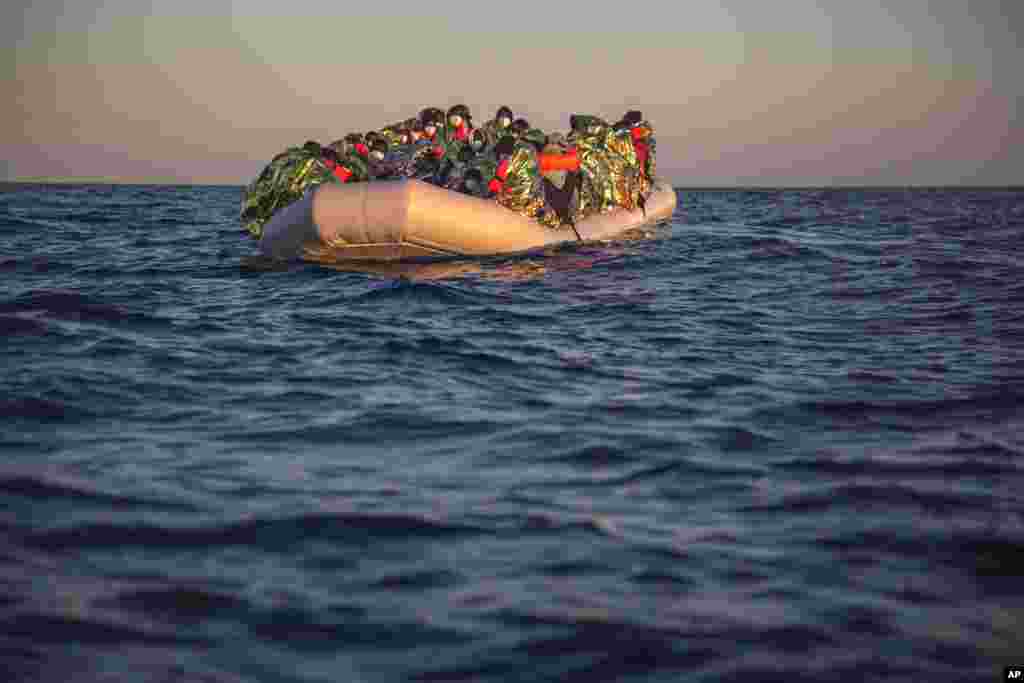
[0,0,1024,185]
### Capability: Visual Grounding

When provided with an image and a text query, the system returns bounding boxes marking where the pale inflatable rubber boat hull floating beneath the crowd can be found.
[253,179,676,263]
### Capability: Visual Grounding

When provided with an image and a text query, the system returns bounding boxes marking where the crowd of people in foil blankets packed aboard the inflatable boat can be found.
[242,104,655,239]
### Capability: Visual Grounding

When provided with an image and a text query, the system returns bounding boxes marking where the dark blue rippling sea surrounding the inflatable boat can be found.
[0,184,1024,683]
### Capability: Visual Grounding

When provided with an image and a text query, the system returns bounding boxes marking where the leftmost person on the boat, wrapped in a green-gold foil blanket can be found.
[240,140,356,240]
